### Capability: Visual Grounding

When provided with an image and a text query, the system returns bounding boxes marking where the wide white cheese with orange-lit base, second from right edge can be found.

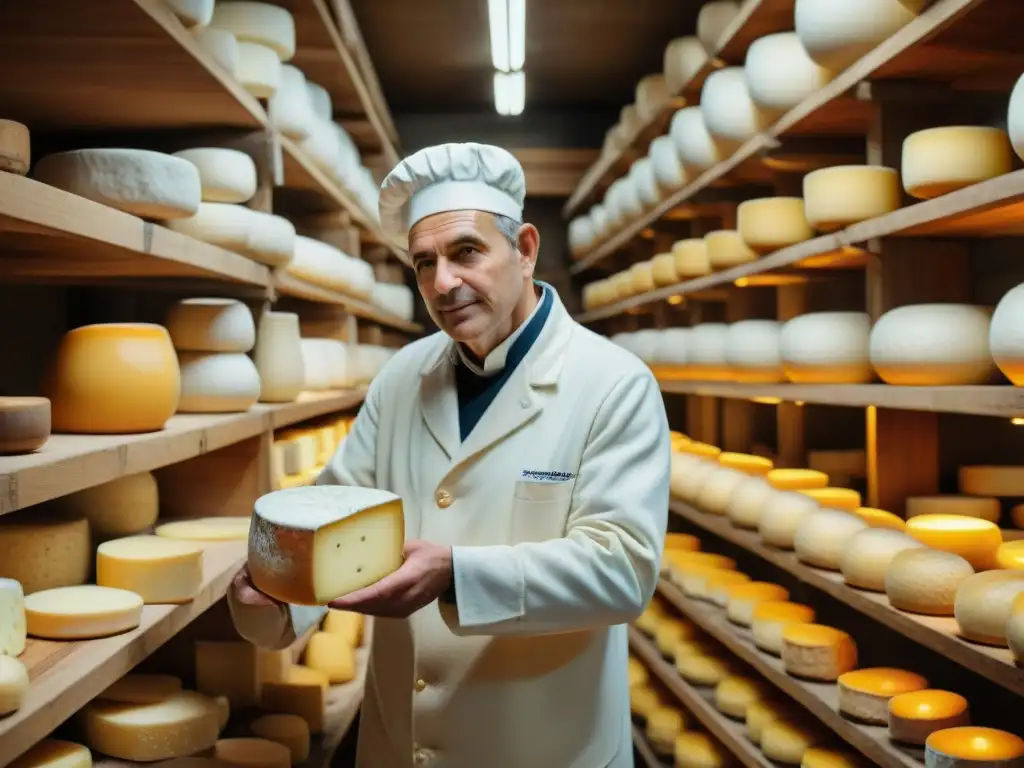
[869,304,995,386]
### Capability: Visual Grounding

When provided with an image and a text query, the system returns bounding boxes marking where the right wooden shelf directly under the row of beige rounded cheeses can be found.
[669,500,1024,695]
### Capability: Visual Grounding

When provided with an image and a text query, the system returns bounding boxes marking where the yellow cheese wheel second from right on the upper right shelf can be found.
[804,165,901,232]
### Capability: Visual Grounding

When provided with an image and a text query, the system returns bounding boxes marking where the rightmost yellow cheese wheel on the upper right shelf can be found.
[900,126,1014,200]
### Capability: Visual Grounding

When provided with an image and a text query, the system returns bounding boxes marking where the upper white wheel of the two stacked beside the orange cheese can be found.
[165,298,256,352]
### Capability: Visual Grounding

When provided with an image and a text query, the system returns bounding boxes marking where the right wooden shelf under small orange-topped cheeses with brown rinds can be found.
[657,580,924,768]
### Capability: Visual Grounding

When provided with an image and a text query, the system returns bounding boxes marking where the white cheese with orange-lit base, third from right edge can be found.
[778,312,872,384]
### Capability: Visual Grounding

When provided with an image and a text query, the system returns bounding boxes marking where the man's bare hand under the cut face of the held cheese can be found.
[329,540,453,618]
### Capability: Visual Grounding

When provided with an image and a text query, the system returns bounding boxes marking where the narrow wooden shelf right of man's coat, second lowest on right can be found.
[629,626,773,768]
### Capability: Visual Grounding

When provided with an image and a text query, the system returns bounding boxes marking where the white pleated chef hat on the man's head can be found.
[380,143,526,256]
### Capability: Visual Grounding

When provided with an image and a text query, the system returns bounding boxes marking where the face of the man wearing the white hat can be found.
[409,211,534,343]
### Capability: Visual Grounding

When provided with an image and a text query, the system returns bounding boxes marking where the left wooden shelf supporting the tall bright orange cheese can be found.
[0,390,364,514]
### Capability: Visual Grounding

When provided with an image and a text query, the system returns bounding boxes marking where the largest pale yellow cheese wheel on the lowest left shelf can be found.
[79,690,218,762]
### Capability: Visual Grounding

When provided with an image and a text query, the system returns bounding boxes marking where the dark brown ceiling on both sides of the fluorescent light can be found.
[352,0,700,118]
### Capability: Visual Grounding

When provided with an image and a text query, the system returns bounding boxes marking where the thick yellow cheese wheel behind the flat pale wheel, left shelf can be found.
[96,536,203,604]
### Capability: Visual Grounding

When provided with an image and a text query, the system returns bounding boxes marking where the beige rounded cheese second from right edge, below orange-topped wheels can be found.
[953,570,1024,648]
